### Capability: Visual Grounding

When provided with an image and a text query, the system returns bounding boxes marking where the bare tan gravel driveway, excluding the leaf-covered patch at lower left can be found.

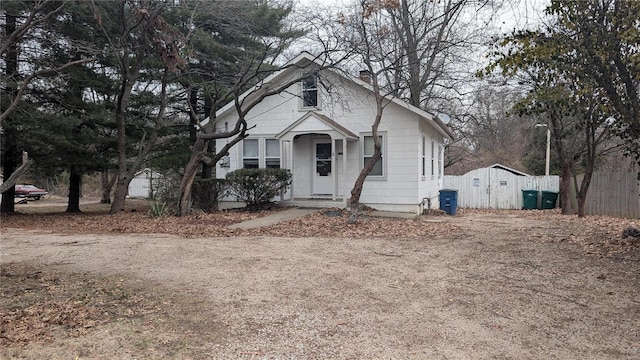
[0,214,640,359]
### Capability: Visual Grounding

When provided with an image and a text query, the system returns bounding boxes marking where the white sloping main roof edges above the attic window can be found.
[216,51,455,140]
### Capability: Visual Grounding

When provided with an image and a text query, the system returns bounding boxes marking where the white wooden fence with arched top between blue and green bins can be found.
[443,167,560,209]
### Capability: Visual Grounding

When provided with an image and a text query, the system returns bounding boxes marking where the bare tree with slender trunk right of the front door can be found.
[322,0,486,222]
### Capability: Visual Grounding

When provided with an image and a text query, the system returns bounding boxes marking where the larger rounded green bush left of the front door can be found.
[227,168,291,210]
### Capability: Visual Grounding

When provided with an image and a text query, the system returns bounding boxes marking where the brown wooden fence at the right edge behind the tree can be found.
[571,172,640,219]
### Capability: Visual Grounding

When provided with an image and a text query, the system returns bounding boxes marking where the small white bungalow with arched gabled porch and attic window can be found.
[215,52,453,214]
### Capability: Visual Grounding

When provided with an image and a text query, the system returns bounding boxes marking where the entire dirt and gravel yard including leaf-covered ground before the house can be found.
[0,201,640,359]
